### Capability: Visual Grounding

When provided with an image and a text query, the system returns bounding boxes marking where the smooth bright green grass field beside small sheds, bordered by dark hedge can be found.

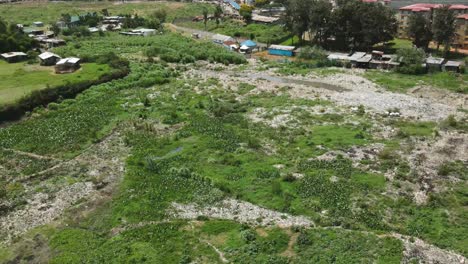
[0,61,110,105]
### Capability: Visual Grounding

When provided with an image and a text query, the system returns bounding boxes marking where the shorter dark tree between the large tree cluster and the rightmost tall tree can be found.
[408,13,432,50]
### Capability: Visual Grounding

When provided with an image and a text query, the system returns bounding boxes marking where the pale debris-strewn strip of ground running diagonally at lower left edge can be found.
[0,131,128,243]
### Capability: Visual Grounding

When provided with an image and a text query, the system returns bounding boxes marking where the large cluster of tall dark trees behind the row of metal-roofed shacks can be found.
[283,0,397,50]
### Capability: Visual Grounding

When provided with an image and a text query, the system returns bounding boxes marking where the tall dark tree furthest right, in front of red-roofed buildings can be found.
[432,5,456,56]
